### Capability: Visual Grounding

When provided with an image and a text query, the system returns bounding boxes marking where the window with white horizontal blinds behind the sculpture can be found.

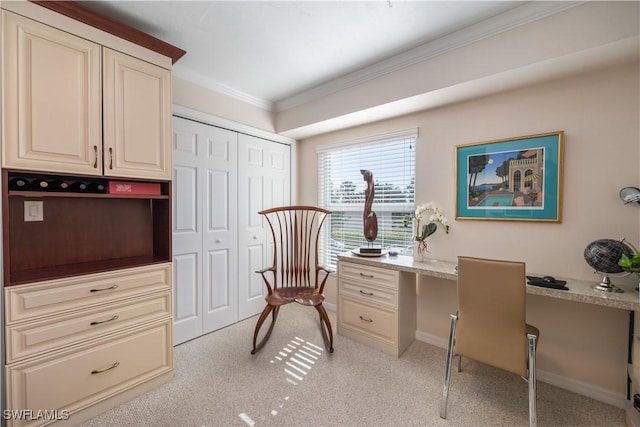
[318,129,417,268]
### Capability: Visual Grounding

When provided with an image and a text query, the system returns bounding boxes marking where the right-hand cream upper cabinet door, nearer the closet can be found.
[103,48,172,179]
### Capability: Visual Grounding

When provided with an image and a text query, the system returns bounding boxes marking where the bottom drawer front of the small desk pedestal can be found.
[338,297,398,343]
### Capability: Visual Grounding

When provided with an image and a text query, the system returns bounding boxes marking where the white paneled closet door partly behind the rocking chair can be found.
[238,134,291,320]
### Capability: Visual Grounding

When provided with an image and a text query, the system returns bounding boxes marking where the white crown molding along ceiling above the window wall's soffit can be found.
[272,1,586,112]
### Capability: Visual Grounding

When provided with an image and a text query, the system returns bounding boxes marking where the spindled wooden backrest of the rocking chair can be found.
[258,206,331,289]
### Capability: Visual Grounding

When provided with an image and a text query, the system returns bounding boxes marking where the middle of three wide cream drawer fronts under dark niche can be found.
[6,292,171,363]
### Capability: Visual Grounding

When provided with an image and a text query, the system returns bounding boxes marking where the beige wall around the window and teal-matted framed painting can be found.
[297,62,640,400]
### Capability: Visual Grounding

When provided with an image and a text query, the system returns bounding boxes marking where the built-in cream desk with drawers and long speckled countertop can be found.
[337,252,640,426]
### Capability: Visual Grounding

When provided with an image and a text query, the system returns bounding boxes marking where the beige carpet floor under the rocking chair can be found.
[83,304,624,427]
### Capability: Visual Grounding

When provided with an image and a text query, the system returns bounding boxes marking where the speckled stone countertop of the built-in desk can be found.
[338,252,640,310]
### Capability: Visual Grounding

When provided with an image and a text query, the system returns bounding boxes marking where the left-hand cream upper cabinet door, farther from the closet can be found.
[2,11,102,175]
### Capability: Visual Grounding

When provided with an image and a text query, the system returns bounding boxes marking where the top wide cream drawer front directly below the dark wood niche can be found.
[5,263,171,325]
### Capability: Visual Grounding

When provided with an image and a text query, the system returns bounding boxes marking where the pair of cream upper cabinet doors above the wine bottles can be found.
[2,10,172,180]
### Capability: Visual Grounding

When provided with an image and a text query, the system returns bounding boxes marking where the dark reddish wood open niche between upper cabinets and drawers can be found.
[2,170,172,286]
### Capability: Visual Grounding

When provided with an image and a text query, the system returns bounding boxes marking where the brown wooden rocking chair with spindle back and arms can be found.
[251,206,333,354]
